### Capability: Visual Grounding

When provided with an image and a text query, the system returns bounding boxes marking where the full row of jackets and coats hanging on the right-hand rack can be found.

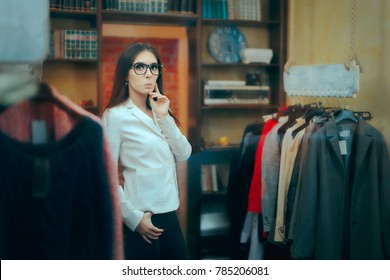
[228,101,389,259]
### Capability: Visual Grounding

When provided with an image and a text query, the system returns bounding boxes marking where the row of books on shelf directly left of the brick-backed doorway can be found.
[48,29,98,60]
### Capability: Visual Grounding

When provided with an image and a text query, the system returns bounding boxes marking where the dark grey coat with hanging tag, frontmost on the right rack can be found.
[291,119,390,259]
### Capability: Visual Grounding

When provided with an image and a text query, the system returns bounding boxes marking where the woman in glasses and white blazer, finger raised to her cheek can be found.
[103,43,192,259]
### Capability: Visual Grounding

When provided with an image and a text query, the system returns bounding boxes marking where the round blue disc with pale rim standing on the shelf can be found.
[208,26,247,63]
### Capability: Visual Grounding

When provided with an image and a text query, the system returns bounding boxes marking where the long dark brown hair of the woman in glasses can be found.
[103,43,179,123]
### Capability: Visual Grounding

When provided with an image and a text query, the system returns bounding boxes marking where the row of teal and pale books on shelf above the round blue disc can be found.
[202,0,261,21]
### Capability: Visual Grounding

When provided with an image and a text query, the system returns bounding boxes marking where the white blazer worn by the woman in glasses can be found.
[103,99,192,231]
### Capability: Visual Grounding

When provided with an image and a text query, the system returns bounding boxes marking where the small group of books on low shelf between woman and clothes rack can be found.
[201,164,229,193]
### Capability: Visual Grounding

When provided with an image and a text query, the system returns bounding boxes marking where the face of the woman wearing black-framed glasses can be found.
[128,51,158,98]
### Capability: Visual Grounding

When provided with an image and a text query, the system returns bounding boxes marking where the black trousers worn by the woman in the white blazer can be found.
[123,212,190,260]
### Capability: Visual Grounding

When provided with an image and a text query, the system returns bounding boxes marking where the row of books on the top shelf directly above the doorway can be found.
[104,0,196,13]
